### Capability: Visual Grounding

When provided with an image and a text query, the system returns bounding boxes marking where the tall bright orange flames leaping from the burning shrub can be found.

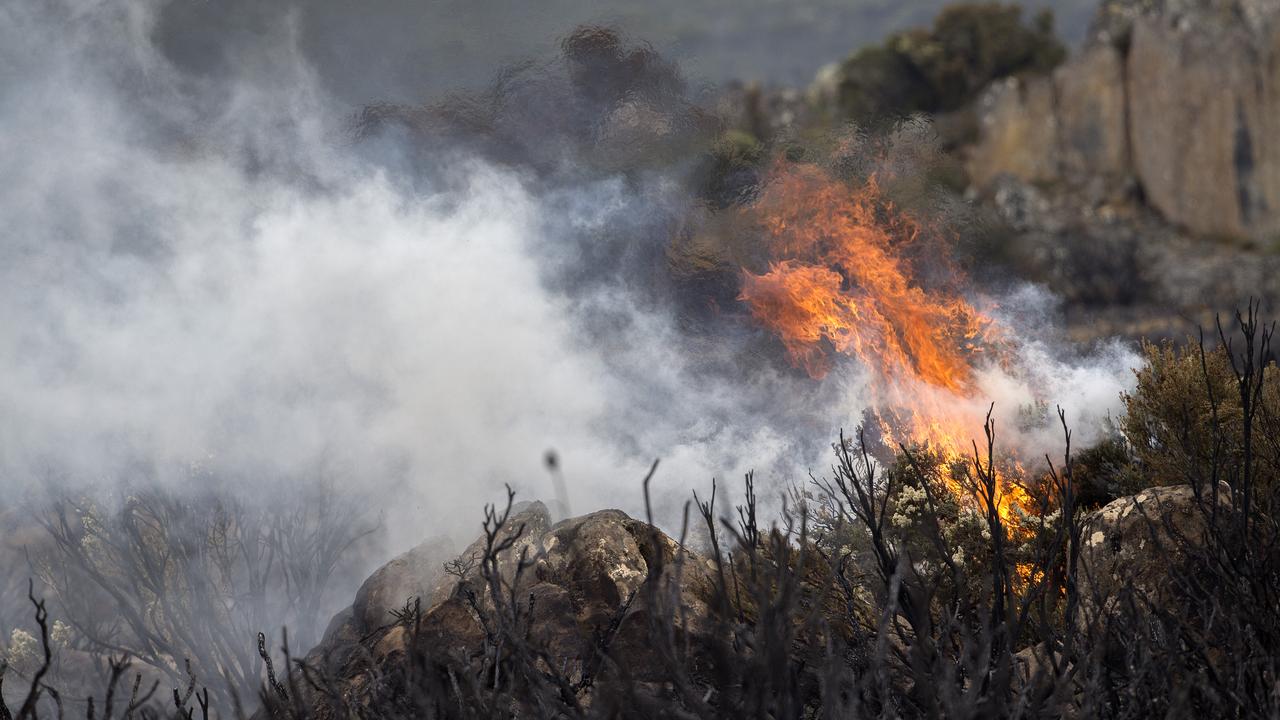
[739,164,1029,524]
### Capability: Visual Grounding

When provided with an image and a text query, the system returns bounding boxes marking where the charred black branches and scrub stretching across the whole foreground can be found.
[0,306,1280,720]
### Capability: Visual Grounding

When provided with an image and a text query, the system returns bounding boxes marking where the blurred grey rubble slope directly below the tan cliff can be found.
[980,174,1280,322]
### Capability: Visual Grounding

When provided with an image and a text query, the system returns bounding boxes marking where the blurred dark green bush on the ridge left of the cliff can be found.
[837,3,1066,124]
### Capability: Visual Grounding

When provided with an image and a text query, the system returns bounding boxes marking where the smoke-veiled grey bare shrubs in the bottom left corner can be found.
[0,486,378,716]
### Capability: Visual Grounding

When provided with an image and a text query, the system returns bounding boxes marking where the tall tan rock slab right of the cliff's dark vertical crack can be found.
[1128,9,1280,238]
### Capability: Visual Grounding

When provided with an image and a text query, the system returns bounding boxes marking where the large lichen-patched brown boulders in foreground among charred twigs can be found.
[308,502,710,716]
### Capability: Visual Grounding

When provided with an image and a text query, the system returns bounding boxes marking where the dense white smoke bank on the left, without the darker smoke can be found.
[0,3,803,542]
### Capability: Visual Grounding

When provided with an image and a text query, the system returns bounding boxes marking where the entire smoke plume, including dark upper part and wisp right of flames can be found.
[0,0,1133,561]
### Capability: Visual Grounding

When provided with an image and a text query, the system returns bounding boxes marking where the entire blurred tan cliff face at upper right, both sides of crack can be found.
[969,0,1280,240]
